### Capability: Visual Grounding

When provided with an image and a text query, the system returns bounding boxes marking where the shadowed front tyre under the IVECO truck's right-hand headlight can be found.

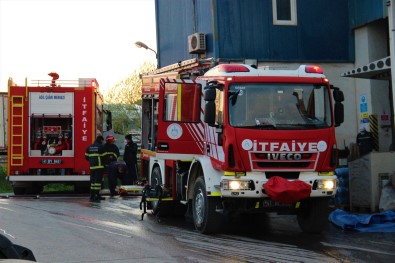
[297,197,329,233]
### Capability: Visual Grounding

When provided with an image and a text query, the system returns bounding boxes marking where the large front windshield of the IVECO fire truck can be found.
[228,83,332,129]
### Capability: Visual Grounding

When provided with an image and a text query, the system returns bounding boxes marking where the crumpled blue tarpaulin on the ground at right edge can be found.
[329,209,395,232]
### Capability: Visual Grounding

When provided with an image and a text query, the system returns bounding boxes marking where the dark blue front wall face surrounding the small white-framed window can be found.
[218,0,352,61]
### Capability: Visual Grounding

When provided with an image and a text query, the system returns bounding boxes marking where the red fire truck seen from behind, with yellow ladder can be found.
[7,72,111,195]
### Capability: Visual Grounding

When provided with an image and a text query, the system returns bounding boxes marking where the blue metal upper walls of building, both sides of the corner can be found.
[156,0,354,67]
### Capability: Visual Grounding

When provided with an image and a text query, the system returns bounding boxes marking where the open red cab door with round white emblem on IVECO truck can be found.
[157,79,205,159]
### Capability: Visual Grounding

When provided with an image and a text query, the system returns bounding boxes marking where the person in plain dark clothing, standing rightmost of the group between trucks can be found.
[123,134,137,185]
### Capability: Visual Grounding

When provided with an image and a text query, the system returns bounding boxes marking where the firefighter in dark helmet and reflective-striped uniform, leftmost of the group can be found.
[85,135,104,203]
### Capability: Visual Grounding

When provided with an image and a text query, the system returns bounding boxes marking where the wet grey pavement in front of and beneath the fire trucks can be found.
[0,195,395,263]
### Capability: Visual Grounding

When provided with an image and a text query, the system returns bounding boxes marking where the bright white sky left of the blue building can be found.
[0,0,156,94]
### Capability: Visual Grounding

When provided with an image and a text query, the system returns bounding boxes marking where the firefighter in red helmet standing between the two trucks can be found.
[102,135,119,197]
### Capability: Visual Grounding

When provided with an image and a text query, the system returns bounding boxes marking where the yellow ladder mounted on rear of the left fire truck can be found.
[9,96,23,166]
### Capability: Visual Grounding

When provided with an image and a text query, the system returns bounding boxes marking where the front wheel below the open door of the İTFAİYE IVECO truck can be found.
[192,177,222,234]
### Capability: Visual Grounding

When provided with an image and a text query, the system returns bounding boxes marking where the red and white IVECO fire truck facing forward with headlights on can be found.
[141,60,344,233]
